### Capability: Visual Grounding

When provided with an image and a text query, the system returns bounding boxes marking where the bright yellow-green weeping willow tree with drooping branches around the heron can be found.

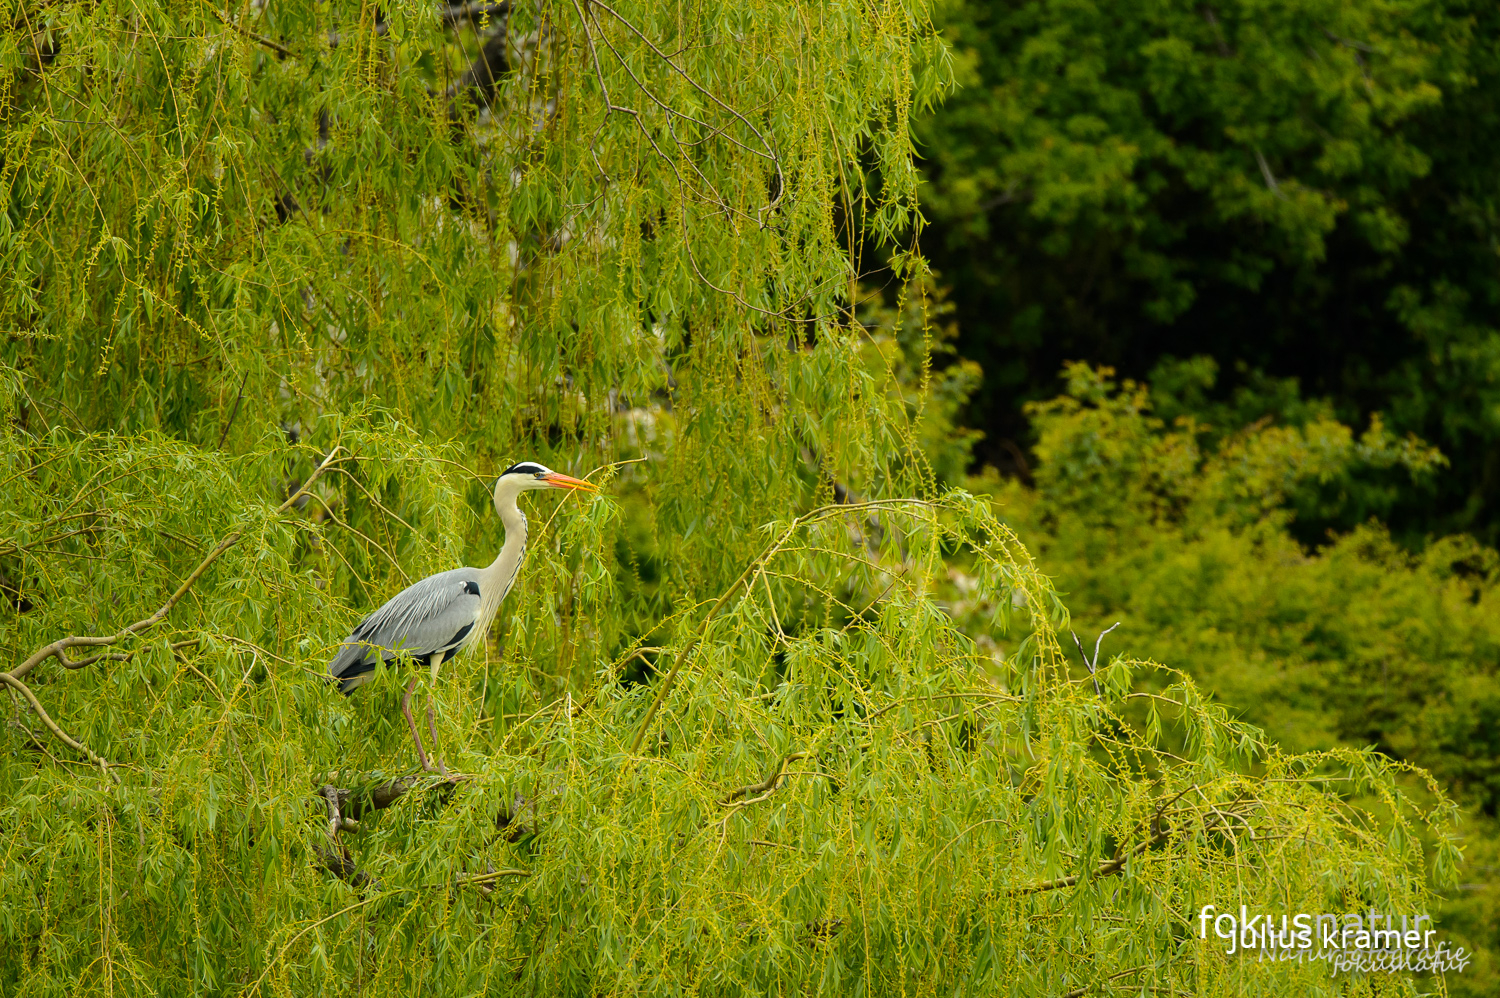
[0,0,1452,995]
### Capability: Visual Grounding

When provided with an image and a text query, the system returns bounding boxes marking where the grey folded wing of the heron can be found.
[329,569,480,693]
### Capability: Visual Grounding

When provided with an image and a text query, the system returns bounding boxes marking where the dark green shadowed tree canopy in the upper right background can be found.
[918,0,1500,543]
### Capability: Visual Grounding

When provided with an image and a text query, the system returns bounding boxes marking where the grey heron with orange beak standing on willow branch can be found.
[329,461,599,776]
